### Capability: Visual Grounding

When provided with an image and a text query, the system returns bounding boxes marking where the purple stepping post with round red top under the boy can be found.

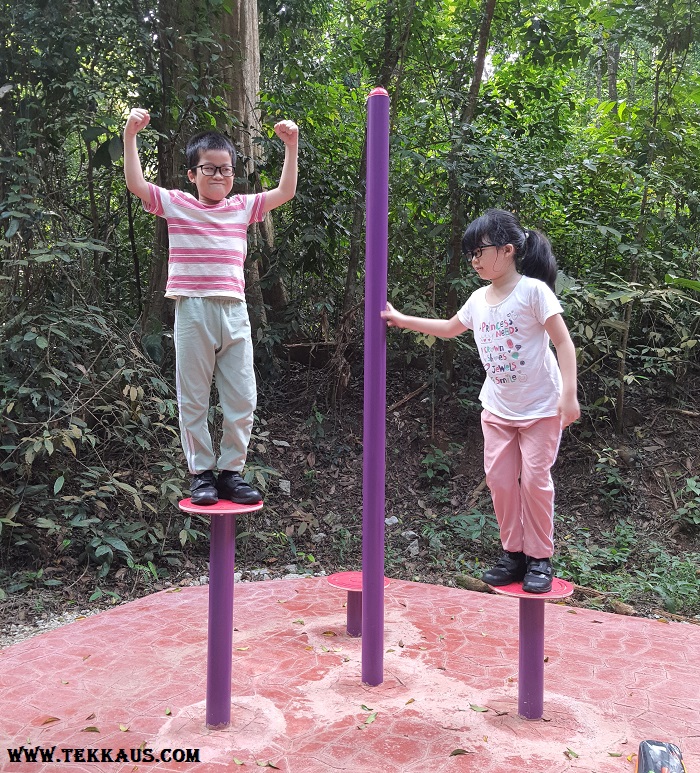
[179,499,263,730]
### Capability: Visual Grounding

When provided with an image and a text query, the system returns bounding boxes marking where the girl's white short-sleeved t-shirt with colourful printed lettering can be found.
[457,276,563,419]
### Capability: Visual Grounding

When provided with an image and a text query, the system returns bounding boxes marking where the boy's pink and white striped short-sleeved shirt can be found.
[143,183,265,301]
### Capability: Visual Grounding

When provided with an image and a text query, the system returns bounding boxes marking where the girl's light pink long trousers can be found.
[481,410,561,558]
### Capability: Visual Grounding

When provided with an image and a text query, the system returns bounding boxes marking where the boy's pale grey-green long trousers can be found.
[174,297,257,475]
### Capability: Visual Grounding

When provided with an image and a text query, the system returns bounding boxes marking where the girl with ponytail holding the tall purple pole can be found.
[382,209,581,593]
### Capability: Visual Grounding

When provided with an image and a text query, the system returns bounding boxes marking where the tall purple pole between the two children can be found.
[362,88,389,685]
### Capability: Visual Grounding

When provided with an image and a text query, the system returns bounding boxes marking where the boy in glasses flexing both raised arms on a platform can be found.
[124,108,299,505]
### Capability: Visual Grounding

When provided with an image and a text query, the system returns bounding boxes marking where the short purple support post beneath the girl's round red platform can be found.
[518,599,544,719]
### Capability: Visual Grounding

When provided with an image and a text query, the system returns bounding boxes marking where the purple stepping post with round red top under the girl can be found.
[489,577,574,719]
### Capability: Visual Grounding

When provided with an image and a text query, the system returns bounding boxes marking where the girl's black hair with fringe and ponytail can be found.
[462,209,557,291]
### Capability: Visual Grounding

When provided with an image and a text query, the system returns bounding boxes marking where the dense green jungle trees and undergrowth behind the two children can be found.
[0,0,700,622]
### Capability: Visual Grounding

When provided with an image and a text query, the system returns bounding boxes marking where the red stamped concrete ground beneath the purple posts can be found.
[0,578,700,773]
